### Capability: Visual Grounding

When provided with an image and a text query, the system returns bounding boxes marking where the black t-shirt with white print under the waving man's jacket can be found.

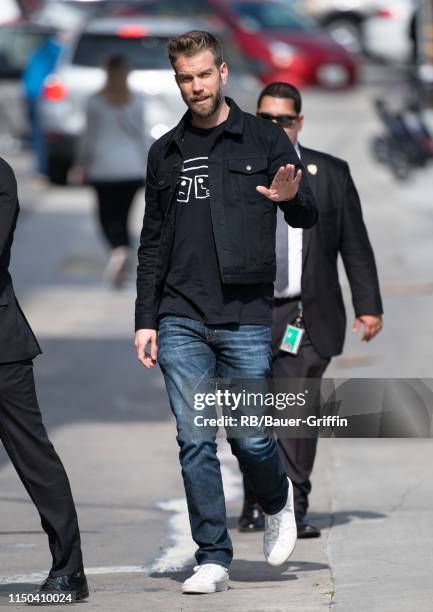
[159,123,274,325]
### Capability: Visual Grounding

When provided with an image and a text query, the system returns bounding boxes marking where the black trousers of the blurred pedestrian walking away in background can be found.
[93,180,143,249]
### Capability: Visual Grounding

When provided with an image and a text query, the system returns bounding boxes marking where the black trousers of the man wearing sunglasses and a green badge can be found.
[272,299,330,519]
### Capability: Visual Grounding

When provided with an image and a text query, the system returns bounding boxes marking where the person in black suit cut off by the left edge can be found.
[0,158,89,602]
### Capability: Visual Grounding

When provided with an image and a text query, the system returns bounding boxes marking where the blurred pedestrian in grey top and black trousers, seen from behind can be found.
[78,55,146,287]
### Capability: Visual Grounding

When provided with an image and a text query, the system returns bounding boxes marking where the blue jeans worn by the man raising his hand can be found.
[158,315,288,567]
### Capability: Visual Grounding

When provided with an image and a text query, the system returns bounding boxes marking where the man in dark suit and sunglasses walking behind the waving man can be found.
[239,83,383,538]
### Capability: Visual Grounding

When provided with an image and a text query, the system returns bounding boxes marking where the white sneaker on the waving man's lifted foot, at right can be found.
[263,478,298,565]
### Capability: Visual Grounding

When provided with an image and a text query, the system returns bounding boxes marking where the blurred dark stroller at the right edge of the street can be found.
[372,100,433,181]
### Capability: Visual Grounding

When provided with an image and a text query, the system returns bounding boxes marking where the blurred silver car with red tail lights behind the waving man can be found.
[39,17,260,184]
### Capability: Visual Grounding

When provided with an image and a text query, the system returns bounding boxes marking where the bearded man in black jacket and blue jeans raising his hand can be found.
[135,31,317,593]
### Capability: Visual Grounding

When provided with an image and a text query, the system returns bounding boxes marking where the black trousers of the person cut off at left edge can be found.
[0,361,83,576]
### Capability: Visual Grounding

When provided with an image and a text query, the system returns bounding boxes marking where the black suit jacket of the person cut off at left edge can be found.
[0,158,41,363]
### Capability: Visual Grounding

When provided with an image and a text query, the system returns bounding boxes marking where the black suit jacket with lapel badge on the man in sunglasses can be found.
[300,146,383,357]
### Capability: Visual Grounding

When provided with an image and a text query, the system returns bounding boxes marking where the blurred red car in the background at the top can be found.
[208,0,357,89]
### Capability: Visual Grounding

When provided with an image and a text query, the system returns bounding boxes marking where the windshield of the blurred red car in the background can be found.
[227,1,317,32]
